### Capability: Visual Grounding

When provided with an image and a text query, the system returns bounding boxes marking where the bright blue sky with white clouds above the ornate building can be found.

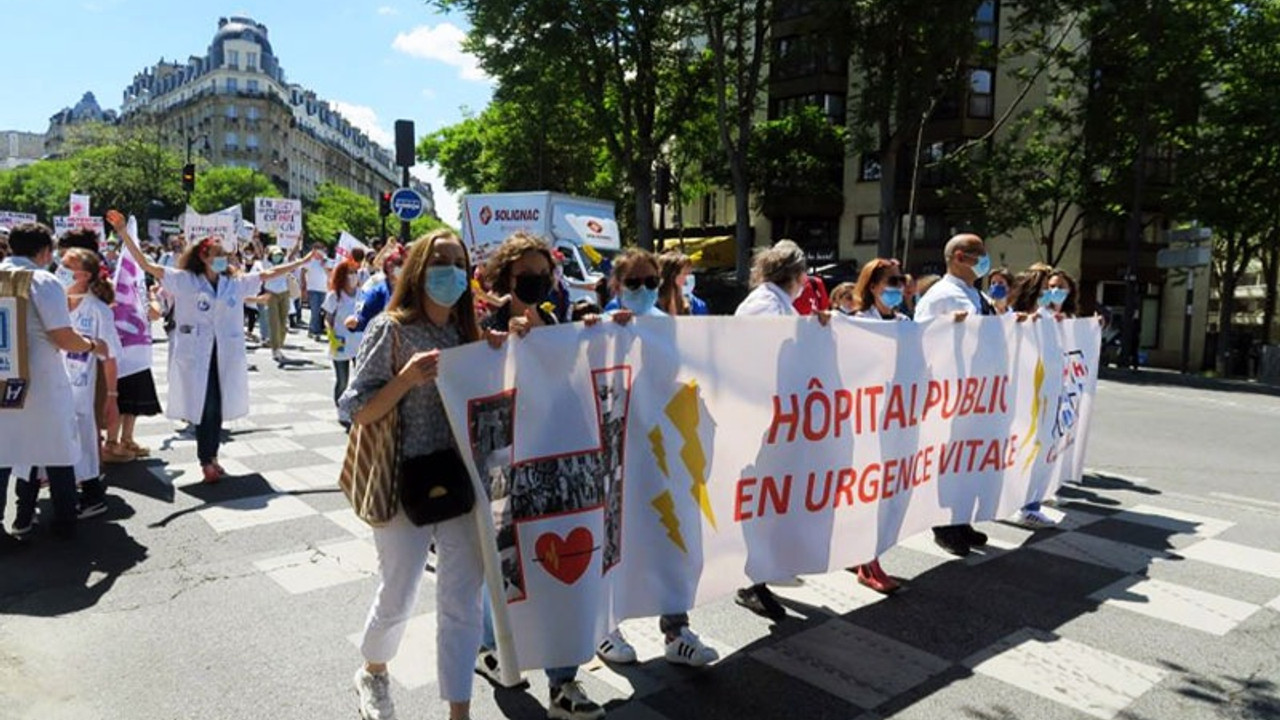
[0,0,492,224]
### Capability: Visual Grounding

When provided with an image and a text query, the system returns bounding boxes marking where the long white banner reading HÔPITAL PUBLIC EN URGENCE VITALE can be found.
[436,316,1101,669]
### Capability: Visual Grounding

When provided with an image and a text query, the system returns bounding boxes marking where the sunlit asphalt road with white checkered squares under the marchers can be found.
[0,336,1280,720]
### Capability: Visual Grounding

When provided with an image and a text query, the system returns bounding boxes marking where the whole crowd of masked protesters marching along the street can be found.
[0,211,1076,720]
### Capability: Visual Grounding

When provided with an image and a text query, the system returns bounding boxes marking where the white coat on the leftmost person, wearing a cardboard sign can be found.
[0,256,81,468]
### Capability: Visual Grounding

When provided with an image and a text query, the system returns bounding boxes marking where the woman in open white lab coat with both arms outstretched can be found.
[106,210,322,483]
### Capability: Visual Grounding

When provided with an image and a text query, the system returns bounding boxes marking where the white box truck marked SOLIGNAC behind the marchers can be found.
[462,192,622,302]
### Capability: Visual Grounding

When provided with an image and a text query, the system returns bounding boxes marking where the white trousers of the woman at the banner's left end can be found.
[360,512,484,702]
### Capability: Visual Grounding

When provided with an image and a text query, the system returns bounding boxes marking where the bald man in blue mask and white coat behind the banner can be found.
[915,233,995,557]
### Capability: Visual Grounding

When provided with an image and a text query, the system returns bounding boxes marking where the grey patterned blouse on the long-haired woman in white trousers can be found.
[338,314,462,457]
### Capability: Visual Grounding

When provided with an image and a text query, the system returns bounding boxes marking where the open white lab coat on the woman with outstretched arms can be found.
[163,268,262,423]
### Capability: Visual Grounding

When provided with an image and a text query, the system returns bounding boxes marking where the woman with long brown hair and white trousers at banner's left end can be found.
[339,229,484,720]
